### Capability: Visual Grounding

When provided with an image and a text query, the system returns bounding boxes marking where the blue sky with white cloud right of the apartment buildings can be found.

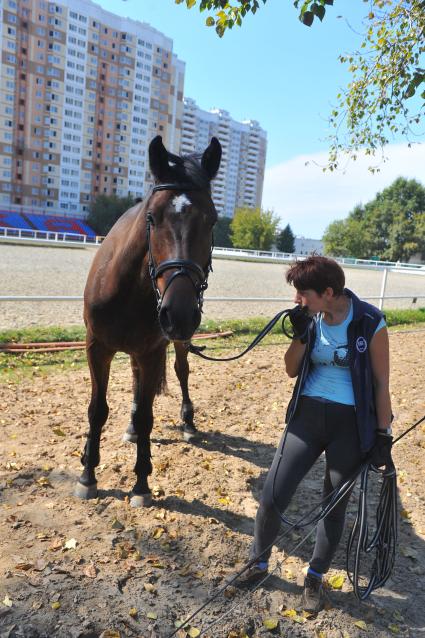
[98,0,425,238]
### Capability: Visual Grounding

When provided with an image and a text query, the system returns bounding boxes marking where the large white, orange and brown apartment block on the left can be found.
[0,0,185,217]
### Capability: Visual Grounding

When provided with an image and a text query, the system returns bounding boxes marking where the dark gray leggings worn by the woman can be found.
[251,397,362,574]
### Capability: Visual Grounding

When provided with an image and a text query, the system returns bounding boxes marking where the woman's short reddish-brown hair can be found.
[286,255,345,297]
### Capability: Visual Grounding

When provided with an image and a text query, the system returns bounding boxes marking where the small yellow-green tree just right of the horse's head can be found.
[231,208,279,250]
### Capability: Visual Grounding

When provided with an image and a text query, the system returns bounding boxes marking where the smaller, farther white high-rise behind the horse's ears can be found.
[181,98,267,217]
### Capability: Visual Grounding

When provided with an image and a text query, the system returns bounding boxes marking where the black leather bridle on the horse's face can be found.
[146,183,213,312]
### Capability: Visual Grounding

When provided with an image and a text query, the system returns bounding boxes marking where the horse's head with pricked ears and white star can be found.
[146,136,221,341]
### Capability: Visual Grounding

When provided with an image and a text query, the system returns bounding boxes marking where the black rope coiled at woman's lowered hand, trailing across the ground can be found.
[167,415,425,638]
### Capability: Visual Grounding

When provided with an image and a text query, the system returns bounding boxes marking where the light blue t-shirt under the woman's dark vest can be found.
[301,303,386,405]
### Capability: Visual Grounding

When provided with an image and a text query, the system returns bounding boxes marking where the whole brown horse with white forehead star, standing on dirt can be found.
[75,136,221,507]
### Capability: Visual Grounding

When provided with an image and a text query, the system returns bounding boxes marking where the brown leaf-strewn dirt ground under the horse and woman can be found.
[0,330,425,638]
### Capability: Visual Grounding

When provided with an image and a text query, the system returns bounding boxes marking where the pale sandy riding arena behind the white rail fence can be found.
[0,244,425,330]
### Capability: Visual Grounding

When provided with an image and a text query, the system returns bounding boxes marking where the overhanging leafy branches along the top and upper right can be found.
[175,0,425,170]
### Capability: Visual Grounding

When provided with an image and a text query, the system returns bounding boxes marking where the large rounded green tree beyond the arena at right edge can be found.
[323,177,425,261]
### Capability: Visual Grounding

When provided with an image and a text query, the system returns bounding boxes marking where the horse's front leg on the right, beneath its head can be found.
[130,349,165,507]
